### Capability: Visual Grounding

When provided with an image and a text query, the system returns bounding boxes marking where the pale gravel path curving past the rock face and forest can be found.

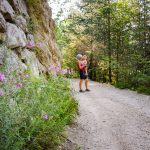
[62,80,150,150]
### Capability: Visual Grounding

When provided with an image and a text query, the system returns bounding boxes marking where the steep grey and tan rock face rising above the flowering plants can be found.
[0,0,61,77]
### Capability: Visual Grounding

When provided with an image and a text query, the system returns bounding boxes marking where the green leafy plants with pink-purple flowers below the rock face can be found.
[0,75,77,150]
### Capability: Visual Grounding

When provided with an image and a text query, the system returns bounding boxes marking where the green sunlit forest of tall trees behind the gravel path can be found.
[56,0,150,94]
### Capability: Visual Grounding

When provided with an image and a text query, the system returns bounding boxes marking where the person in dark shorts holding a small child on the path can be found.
[77,54,90,92]
